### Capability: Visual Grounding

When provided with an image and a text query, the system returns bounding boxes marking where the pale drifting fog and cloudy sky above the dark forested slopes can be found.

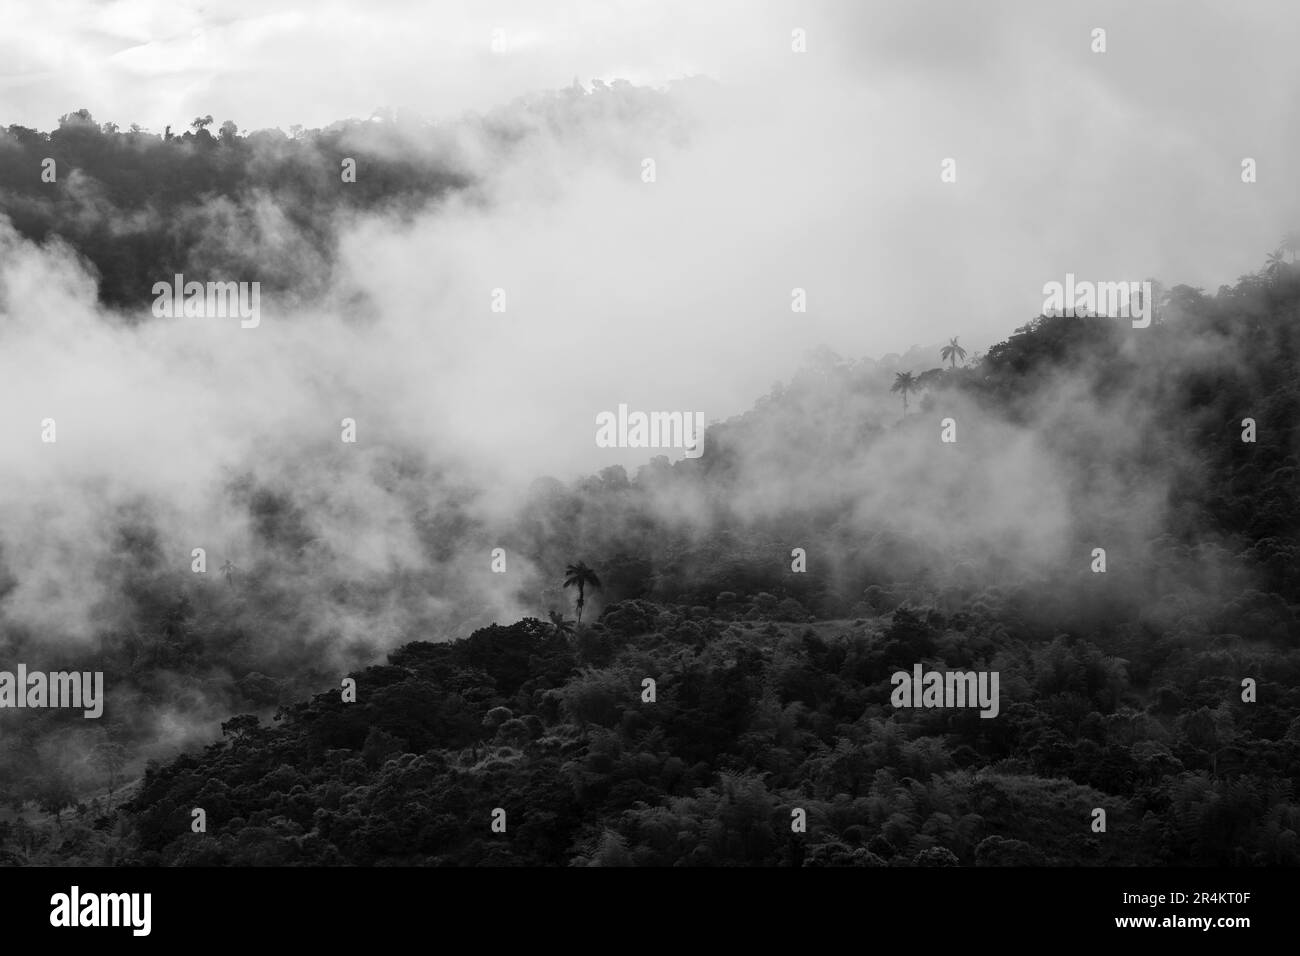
[0,3,1284,790]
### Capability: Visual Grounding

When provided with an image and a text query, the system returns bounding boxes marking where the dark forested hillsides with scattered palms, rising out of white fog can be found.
[0,85,1300,866]
